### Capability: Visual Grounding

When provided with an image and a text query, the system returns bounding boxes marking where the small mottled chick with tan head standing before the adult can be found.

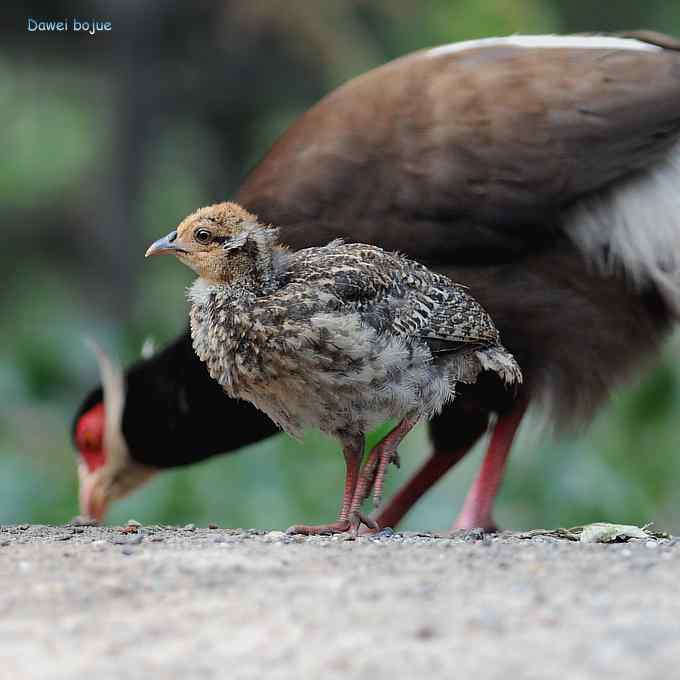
[146,203,522,534]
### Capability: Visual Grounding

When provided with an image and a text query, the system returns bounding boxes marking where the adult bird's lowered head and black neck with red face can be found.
[73,332,279,521]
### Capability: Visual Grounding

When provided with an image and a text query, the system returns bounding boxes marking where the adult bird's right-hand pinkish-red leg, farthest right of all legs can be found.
[453,401,527,529]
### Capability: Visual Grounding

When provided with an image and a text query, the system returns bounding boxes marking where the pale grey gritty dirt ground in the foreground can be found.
[0,525,680,680]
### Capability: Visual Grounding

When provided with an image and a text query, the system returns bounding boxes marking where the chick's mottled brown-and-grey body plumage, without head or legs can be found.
[189,242,519,436]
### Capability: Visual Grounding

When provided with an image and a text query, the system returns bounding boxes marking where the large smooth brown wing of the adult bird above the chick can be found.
[238,37,680,254]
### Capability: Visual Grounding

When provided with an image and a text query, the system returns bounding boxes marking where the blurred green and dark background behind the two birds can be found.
[0,0,680,531]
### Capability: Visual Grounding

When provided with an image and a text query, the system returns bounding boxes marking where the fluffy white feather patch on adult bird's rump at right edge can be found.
[566,145,680,316]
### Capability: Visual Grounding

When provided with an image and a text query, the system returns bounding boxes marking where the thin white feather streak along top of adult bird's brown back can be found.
[425,35,663,57]
